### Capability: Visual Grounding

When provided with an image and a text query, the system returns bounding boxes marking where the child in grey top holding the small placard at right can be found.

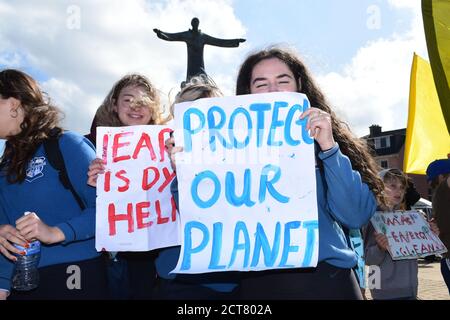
[365,169,438,300]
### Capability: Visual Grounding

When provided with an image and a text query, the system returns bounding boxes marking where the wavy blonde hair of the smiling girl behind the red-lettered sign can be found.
[95,74,164,127]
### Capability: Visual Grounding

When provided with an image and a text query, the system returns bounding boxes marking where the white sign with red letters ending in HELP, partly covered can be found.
[96,126,179,251]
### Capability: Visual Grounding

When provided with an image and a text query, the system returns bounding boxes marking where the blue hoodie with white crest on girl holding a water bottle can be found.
[0,132,99,290]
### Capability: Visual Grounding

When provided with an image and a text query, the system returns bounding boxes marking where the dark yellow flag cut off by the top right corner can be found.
[422,0,450,134]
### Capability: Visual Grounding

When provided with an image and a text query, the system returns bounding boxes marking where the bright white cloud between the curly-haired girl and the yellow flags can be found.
[318,0,427,136]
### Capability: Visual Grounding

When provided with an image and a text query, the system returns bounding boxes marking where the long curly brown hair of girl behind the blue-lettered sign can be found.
[236,47,386,208]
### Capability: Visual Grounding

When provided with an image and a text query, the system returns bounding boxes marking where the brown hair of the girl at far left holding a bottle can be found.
[0,69,61,183]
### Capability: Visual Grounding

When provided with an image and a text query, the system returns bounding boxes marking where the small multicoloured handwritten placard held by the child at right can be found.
[371,211,447,260]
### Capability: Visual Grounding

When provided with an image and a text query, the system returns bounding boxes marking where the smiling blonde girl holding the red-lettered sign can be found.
[87,74,165,299]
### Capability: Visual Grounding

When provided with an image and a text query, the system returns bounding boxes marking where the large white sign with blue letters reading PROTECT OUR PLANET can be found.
[173,93,318,273]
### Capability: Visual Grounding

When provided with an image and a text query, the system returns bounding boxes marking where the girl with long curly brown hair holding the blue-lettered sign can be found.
[236,48,384,299]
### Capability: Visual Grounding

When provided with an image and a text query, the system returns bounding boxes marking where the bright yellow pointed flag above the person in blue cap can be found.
[403,54,450,174]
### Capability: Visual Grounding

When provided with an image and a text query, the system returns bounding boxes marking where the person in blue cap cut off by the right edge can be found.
[427,159,450,293]
